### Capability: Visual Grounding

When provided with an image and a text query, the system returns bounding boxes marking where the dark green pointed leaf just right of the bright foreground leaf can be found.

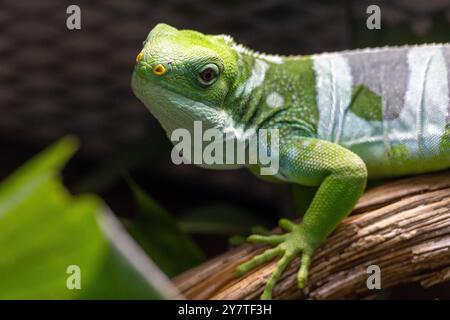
[125,178,205,277]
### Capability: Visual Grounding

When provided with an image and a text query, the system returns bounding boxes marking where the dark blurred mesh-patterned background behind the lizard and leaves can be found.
[0,0,450,298]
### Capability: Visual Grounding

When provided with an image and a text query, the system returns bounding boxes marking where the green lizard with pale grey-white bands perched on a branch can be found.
[132,24,450,299]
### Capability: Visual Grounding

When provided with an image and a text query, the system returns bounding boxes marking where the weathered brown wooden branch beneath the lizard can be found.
[173,171,450,299]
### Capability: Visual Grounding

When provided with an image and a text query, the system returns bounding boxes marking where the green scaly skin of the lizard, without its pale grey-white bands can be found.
[132,24,450,299]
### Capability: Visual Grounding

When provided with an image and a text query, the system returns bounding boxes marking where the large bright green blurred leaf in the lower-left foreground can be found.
[0,138,178,299]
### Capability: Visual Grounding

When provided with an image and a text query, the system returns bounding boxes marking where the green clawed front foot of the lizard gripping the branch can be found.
[236,219,314,300]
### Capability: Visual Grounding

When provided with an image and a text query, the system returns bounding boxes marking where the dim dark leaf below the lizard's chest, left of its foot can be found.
[178,204,267,236]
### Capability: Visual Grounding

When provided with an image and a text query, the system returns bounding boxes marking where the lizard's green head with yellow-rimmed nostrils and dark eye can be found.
[132,24,238,137]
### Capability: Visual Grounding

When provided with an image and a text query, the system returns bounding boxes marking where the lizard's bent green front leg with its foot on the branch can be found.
[237,138,367,299]
